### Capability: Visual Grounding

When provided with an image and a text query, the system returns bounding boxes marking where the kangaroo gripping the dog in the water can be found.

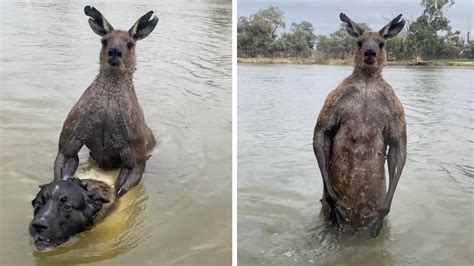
[54,6,158,196]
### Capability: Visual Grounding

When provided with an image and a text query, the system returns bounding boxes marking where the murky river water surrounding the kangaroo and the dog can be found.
[0,0,232,265]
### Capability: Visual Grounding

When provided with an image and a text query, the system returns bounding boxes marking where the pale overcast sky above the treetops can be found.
[237,0,474,35]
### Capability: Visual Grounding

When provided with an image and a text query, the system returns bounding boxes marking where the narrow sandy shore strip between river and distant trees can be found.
[237,57,474,67]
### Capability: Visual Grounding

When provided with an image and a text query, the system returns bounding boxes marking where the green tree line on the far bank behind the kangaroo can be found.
[237,0,474,60]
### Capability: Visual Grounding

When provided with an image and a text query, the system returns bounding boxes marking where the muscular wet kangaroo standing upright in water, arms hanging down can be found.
[313,13,406,237]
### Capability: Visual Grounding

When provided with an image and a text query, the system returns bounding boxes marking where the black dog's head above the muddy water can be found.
[29,179,109,251]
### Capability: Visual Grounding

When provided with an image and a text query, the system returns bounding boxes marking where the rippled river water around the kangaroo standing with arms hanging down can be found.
[238,64,474,266]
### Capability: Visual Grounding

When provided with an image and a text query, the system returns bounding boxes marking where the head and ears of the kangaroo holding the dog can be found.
[84,6,158,73]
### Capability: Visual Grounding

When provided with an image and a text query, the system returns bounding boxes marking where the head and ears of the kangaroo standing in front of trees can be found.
[339,13,405,74]
